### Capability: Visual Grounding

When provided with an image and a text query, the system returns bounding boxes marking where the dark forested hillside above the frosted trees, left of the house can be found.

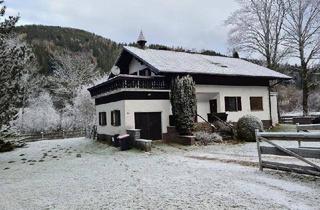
[16,25,121,74]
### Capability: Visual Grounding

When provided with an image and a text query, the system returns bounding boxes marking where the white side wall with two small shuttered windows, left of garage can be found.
[96,100,126,135]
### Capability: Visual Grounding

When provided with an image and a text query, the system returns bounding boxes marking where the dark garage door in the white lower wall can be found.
[134,112,162,140]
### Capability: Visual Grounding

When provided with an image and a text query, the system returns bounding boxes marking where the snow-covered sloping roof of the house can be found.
[124,46,291,79]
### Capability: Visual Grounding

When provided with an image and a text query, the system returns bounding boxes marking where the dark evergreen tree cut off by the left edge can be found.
[0,1,32,132]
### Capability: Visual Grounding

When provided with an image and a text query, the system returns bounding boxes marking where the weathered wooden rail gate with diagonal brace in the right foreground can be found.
[256,130,320,176]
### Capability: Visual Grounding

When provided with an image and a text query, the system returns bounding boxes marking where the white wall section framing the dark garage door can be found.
[125,100,171,133]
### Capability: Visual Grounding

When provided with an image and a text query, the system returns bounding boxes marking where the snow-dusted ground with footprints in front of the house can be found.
[0,138,320,210]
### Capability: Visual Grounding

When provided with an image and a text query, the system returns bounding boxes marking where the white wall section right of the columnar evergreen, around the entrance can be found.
[196,85,270,122]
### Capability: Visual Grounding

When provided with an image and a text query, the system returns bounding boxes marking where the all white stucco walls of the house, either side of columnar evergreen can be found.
[96,85,278,135]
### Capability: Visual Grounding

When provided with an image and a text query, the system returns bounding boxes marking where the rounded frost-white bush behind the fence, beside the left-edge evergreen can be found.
[12,92,59,132]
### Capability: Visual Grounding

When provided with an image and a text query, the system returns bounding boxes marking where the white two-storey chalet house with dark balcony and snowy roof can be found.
[88,33,290,140]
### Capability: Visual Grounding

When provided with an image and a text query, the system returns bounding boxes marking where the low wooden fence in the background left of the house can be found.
[19,130,86,142]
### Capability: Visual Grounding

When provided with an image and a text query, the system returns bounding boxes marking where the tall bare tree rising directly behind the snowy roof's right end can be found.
[226,0,289,68]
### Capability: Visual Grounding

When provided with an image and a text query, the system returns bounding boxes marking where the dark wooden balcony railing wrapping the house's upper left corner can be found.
[88,75,169,97]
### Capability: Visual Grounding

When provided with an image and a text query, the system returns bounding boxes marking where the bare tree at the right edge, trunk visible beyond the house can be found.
[283,0,320,115]
